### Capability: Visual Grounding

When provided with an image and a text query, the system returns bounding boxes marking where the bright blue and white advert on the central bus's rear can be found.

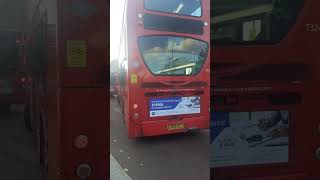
[150,96,200,117]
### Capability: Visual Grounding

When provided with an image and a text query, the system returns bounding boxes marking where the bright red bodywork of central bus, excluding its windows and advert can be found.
[119,0,210,138]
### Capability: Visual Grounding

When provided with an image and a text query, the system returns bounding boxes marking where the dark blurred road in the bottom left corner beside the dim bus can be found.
[0,106,40,180]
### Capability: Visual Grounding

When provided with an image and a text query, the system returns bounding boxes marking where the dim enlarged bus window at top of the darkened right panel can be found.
[211,0,304,44]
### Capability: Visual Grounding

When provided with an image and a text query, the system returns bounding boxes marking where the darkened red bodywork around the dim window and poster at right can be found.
[211,0,320,180]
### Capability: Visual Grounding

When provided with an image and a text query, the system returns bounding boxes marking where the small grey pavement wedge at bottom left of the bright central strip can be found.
[110,154,132,180]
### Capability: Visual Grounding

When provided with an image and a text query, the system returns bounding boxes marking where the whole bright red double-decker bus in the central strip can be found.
[119,0,210,138]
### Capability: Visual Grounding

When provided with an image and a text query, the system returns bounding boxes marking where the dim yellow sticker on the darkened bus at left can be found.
[67,40,87,68]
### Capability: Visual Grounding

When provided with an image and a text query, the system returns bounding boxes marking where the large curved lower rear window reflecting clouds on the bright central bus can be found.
[138,36,208,76]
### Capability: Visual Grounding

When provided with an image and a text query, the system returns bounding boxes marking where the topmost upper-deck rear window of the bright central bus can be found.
[144,0,202,17]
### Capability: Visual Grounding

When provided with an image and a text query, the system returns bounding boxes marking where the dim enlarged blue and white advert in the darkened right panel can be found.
[210,111,289,168]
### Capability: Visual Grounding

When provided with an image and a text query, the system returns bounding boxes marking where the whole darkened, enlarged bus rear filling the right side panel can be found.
[210,0,320,180]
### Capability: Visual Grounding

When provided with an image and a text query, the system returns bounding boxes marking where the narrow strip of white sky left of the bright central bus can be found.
[110,0,125,62]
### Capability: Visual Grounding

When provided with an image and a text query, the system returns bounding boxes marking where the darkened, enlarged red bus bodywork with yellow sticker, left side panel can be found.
[25,0,109,180]
